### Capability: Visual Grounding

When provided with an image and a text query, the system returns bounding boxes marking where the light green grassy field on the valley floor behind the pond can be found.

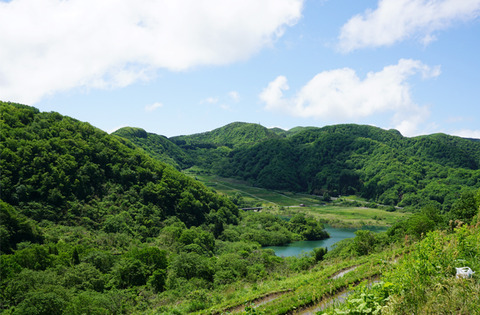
[186,172,409,227]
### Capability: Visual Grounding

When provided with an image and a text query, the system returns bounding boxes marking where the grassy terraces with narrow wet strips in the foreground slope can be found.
[193,249,402,314]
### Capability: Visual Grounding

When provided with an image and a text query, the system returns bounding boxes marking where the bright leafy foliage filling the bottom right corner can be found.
[325,225,480,314]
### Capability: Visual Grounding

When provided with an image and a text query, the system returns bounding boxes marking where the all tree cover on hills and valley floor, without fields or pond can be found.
[0,102,480,314]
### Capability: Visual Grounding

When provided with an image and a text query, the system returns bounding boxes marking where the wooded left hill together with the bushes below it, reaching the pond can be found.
[0,102,328,314]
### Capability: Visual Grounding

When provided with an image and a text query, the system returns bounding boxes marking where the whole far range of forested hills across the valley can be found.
[118,122,480,211]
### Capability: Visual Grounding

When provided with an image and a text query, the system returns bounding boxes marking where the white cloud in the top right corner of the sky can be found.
[339,0,480,52]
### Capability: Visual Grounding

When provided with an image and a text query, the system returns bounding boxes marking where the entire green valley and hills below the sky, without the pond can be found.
[0,102,480,314]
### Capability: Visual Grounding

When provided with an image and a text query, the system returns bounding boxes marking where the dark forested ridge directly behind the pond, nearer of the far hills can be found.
[217,125,480,210]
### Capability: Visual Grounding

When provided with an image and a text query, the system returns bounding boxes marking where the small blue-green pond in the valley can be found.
[264,226,387,257]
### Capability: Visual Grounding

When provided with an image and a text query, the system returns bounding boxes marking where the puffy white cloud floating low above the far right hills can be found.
[260,59,440,135]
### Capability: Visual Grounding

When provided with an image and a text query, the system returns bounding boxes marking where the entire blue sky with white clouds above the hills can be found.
[0,0,480,138]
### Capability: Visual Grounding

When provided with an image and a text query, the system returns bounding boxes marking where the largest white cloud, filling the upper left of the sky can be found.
[0,0,303,103]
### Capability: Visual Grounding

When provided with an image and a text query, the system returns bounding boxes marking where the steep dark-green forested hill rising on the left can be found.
[0,102,238,252]
